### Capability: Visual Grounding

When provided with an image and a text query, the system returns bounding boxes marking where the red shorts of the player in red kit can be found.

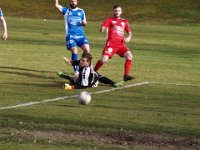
[103,41,129,58]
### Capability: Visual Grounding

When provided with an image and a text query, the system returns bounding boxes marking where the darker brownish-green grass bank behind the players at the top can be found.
[0,0,200,24]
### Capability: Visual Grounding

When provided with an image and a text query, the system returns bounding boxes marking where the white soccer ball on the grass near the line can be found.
[77,91,91,105]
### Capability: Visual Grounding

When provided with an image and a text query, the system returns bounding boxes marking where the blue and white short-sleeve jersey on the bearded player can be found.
[62,7,85,36]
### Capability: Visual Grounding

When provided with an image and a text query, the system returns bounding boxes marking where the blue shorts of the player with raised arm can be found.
[66,35,89,50]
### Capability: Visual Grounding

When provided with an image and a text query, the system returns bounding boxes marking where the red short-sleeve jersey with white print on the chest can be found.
[101,17,131,44]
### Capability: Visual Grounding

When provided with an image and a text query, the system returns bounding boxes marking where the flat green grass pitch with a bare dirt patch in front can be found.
[0,18,200,150]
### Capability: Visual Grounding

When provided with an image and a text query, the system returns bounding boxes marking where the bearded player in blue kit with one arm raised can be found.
[55,0,90,75]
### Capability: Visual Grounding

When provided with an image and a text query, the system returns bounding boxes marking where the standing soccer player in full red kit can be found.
[94,5,135,81]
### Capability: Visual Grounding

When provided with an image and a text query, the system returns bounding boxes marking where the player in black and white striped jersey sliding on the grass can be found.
[57,53,121,90]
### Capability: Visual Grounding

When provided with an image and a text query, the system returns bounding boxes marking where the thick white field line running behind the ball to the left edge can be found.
[0,82,149,110]
